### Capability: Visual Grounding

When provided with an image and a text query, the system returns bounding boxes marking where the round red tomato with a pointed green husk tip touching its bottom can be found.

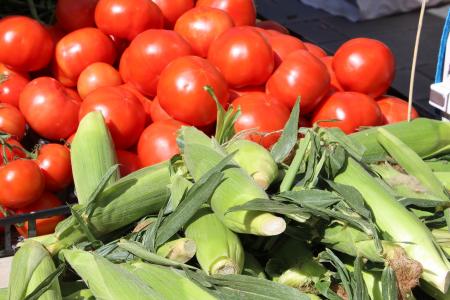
[266,50,330,114]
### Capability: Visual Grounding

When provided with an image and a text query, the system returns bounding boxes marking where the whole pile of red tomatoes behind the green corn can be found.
[0,0,417,235]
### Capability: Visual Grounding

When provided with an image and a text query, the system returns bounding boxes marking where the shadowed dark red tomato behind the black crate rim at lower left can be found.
[15,192,64,238]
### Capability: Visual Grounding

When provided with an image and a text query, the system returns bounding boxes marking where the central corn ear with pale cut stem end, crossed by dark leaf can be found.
[180,127,286,236]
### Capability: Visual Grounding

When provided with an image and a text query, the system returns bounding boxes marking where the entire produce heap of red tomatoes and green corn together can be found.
[0,0,450,300]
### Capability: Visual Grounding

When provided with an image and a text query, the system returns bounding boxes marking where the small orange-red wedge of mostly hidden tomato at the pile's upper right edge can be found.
[266,34,306,67]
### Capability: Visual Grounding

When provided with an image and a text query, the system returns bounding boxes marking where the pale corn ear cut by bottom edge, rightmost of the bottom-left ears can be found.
[124,262,216,300]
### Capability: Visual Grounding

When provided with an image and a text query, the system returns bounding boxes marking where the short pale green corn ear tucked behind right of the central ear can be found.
[226,140,278,190]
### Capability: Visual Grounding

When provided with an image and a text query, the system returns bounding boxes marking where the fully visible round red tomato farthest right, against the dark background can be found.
[333,38,395,98]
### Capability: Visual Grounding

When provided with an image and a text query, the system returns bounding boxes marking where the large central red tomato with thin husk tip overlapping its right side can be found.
[158,56,228,126]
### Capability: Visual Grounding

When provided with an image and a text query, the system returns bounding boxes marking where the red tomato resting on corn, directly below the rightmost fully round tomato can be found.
[311,92,382,134]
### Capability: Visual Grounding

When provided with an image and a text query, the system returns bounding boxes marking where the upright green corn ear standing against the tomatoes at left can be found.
[70,111,120,204]
